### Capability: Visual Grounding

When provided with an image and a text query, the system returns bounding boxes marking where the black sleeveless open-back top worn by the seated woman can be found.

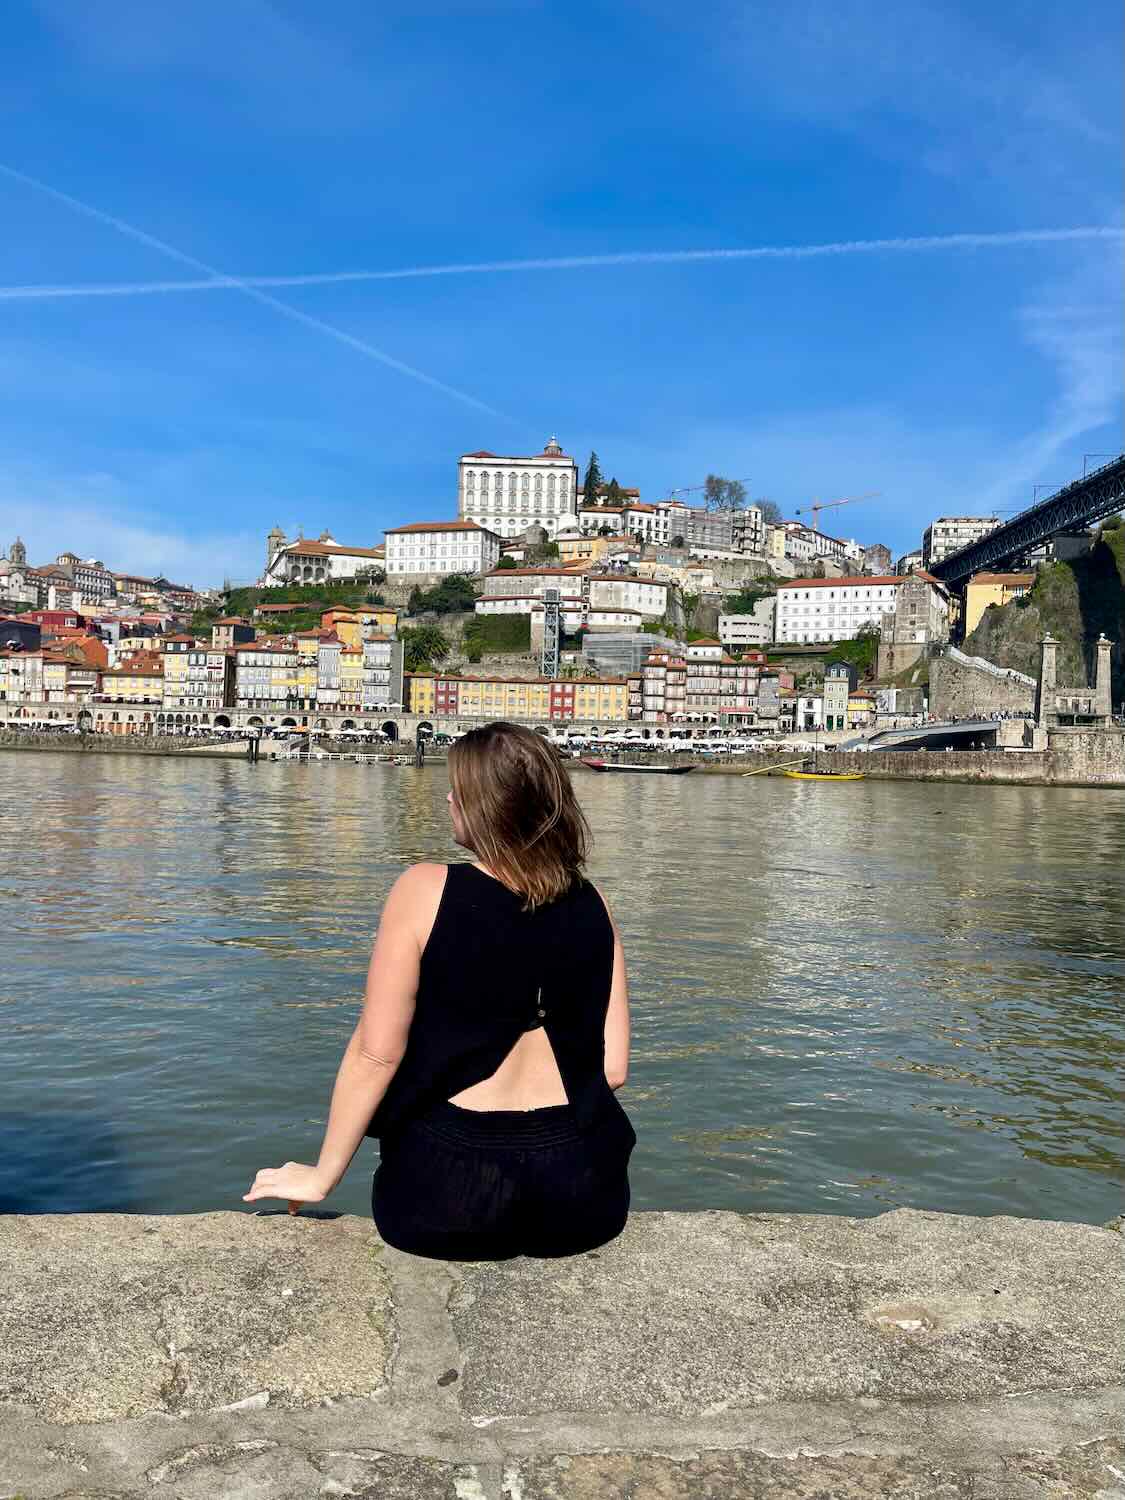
[366,864,623,1137]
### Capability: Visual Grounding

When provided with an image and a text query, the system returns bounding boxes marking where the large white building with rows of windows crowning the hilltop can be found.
[458,438,578,537]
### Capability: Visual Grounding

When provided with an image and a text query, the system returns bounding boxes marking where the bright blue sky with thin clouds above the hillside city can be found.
[0,0,1122,584]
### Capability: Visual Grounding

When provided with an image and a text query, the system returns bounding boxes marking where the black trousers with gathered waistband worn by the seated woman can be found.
[371,1098,636,1260]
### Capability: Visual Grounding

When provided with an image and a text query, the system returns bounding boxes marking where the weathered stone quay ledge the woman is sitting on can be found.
[0,1209,1125,1500]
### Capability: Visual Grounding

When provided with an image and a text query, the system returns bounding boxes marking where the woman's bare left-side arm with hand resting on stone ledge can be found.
[243,864,446,1203]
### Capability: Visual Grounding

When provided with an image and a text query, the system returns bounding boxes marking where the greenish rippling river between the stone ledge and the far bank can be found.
[0,752,1125,1223]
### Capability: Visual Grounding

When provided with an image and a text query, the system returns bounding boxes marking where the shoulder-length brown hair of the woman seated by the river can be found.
[449,720,590,911]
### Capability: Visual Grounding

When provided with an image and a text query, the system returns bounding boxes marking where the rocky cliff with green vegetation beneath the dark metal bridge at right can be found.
[965,518,1125,702]
